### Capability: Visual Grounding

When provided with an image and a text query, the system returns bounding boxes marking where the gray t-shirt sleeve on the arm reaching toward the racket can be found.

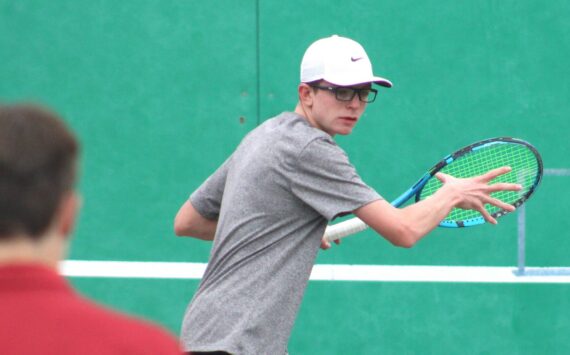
[291,138,382,221]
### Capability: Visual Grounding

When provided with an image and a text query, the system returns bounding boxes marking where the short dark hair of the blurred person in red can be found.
[0,103,79,239]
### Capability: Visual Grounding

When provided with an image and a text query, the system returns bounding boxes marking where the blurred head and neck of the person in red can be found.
[0,104,79,264]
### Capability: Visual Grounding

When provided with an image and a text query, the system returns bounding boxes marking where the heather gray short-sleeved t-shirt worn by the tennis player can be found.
[181,112,381,355]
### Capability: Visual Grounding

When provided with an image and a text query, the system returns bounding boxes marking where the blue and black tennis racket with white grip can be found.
[325,137,543,242]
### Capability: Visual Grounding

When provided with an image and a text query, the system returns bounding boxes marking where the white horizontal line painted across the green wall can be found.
[60,260,570,283]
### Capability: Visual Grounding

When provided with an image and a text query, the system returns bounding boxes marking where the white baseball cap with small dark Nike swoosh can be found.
[301,35,392,88]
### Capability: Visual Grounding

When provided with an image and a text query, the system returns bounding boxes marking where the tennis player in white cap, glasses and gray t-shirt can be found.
[174,36,519,354]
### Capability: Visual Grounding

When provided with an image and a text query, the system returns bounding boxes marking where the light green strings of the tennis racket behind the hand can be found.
[420,142,539,221]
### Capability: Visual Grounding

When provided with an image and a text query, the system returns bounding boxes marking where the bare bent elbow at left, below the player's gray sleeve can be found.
[174,200,218,240]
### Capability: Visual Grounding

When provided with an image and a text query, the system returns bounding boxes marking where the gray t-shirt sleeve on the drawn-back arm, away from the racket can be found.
[190,157,231,220]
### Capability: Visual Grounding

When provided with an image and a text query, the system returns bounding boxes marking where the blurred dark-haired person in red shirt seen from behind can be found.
[0,105,181,355]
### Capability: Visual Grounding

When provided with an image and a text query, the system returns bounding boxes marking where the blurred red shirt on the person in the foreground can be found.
[0,265,181,355]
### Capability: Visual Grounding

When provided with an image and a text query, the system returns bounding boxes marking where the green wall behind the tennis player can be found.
[0,0,570,354]
